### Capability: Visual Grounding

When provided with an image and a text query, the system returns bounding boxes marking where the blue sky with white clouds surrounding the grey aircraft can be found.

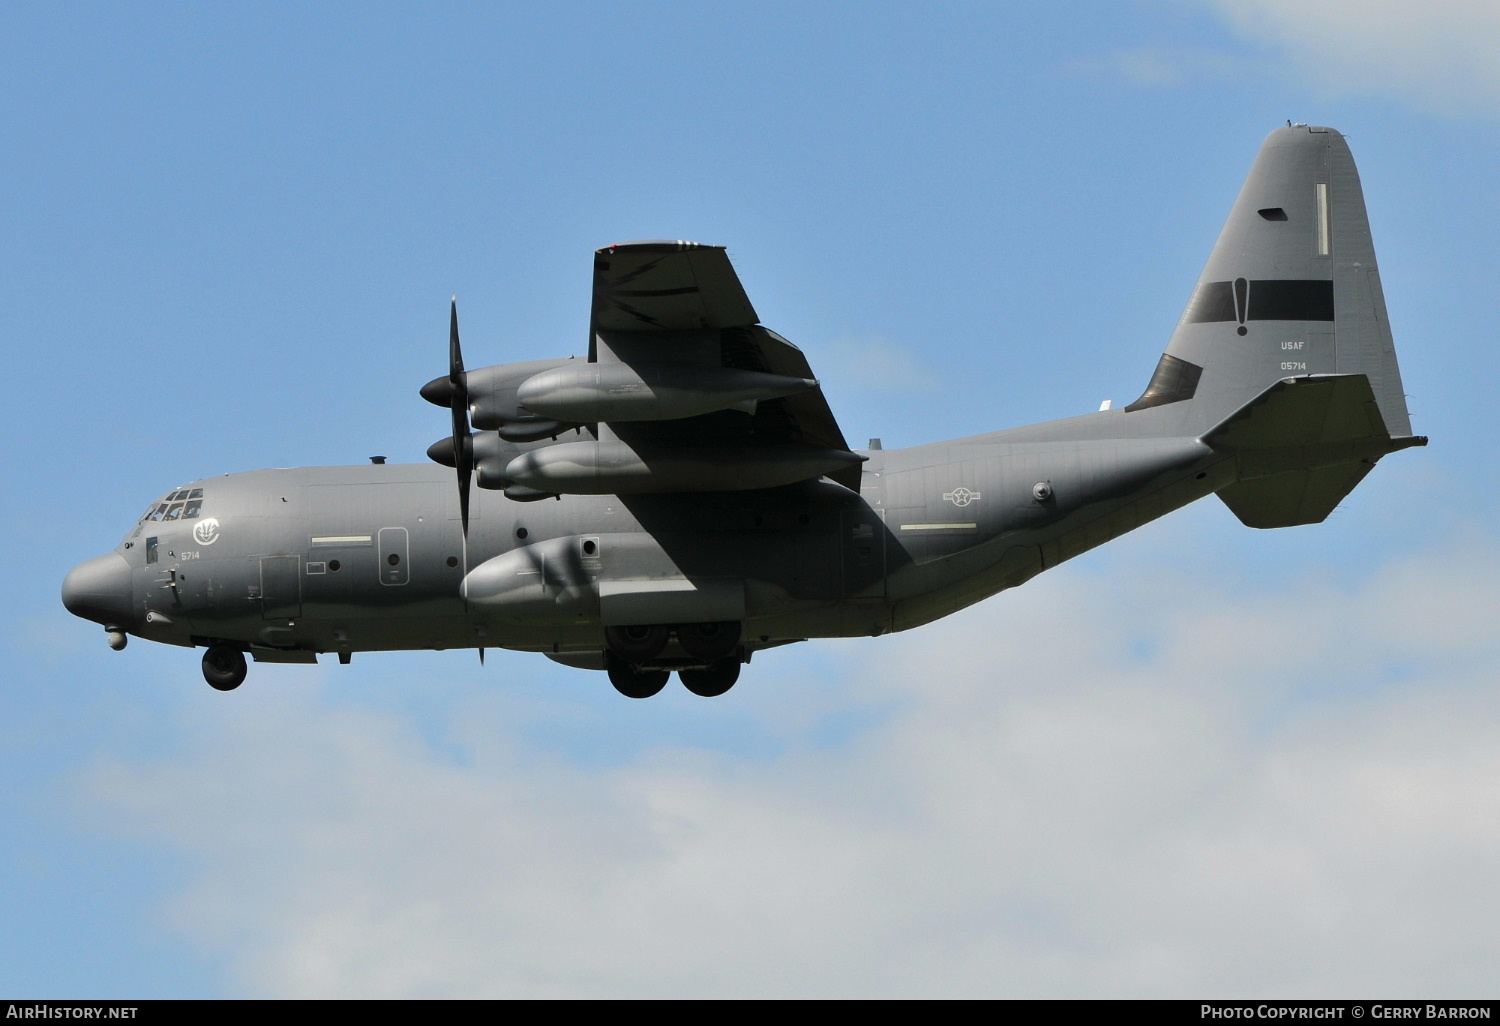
[0,0,1500,998]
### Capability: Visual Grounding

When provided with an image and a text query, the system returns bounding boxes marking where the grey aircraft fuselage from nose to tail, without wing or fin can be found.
[64,413,1229,656]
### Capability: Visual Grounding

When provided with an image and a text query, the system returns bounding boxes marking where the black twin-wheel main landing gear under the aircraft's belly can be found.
[605,621,740,699]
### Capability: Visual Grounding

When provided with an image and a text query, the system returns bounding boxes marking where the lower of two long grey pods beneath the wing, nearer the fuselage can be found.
[503,440,867,495]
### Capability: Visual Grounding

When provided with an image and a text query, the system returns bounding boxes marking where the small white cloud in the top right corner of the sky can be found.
[1205,0,1500,113]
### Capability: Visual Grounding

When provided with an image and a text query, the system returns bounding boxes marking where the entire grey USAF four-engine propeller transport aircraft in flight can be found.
[63,125,1427,698]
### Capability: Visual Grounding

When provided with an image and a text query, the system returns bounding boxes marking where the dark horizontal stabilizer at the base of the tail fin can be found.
[1203,374,1427,528]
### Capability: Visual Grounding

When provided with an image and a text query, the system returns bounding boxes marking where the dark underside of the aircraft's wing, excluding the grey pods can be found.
[588,242,860,491]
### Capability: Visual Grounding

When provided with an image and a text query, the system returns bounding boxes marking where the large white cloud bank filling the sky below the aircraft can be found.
[79,542,1500,996]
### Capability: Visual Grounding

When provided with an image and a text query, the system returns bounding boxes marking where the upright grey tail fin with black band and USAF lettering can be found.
[1128,125,1412,437]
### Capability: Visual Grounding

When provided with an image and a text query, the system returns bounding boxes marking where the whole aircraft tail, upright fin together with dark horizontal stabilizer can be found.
[1127,125,1427,527]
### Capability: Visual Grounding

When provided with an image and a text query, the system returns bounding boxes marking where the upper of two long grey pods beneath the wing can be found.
[516,362,818,423]
